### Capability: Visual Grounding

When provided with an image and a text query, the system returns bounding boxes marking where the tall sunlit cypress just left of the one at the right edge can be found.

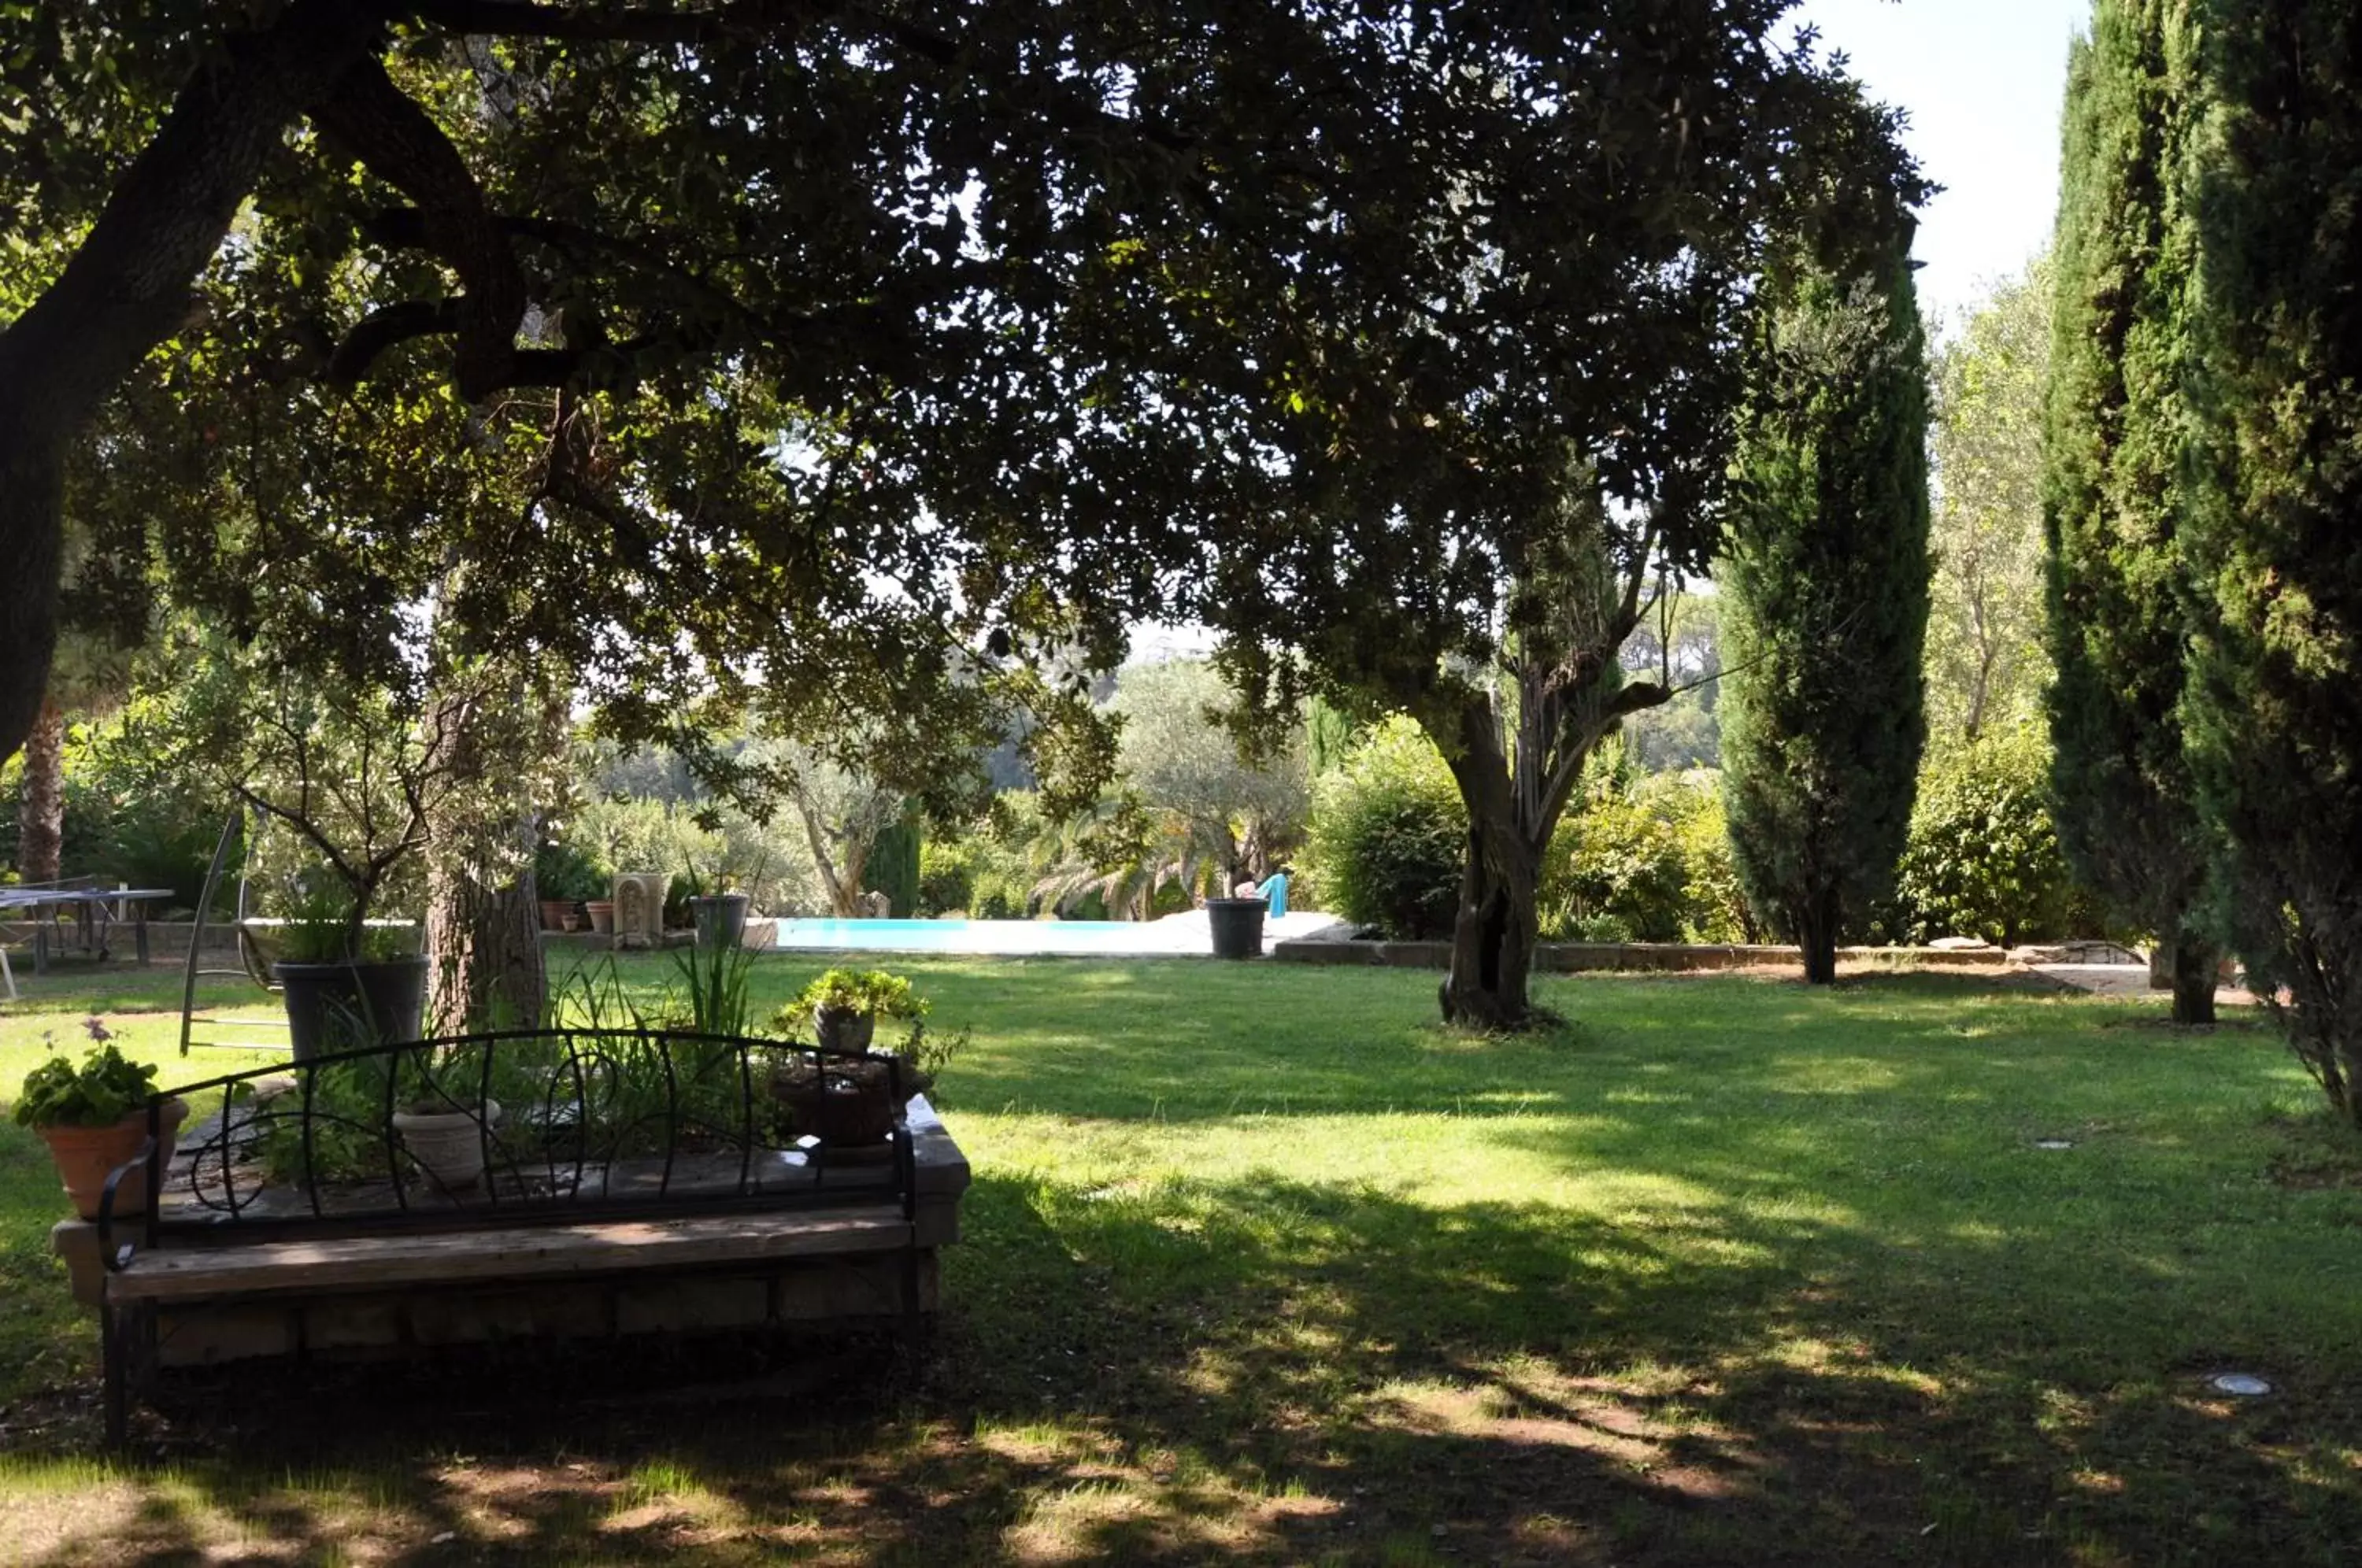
[2043,0,2216,1023]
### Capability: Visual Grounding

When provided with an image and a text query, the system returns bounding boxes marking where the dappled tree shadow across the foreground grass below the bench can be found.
[23,1174,2362,1563]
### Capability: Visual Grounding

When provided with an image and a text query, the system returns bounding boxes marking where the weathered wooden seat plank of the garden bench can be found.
[106,1204,912,1301]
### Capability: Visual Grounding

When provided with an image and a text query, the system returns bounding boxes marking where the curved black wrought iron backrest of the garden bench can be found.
[99,1027,914,1266]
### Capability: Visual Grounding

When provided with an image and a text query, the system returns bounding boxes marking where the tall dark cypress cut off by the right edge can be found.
[2185,0,2362,1124]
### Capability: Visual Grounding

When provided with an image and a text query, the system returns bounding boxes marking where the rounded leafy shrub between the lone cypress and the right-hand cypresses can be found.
[1887,725,2076,947]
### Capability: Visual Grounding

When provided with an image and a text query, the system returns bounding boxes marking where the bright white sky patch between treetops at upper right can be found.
[1793,0,2090,326]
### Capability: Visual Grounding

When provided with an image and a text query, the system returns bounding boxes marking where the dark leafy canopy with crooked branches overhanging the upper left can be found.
[13,0,1720,770]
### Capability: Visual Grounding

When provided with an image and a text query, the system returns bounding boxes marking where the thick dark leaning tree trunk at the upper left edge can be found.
[0,0,385,760]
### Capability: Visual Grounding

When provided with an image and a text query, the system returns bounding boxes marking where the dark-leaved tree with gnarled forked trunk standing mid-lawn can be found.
[1202,12,1920,1027]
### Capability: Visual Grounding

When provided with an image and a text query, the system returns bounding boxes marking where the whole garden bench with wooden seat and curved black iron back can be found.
[85,1030,968,1443]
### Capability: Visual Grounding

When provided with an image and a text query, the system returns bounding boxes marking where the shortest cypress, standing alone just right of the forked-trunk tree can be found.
[1717,230,1930,985]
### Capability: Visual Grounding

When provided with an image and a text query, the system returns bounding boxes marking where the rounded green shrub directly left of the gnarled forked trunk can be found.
[1306,718,1469,937]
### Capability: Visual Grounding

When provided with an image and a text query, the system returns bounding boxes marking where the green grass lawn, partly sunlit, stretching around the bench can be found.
[0,959,2362,1566]
